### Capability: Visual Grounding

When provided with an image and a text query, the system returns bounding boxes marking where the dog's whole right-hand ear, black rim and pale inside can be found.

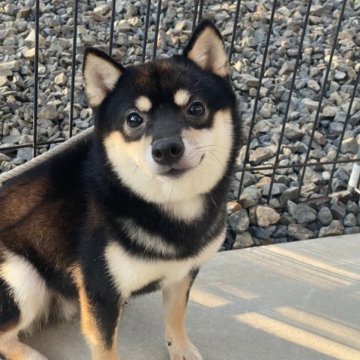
[183,20,230,77]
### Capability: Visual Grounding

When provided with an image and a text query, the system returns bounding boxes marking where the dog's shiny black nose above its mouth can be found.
[152,137,185,165]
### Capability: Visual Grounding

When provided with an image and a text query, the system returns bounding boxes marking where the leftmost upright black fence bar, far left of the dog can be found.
[33,0,40,157]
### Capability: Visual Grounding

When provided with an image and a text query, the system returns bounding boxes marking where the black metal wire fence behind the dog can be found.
[0,0,360,203]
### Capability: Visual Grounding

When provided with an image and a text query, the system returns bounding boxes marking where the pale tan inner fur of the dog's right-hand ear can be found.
[188,27,230,76]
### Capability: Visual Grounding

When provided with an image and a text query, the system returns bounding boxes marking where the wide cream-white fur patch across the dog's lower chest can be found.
[105,232,224,298]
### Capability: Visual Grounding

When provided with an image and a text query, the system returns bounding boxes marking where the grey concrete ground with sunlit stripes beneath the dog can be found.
[27,235,360,360]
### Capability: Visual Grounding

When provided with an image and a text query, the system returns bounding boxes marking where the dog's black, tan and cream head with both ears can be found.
[84,21,239,203]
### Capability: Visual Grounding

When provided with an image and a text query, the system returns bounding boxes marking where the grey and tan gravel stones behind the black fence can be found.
[0,0,360,248]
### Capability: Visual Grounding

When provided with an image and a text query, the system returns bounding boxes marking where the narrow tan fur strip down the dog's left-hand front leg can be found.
[73,267,118,360]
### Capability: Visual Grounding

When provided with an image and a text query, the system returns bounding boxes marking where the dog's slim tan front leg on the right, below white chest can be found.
[163,271,202,360]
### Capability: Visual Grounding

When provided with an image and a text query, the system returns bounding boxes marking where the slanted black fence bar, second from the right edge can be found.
[298,0,346,197]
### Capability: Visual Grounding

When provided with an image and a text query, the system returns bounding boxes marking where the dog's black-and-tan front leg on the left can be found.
[76,271,121,360]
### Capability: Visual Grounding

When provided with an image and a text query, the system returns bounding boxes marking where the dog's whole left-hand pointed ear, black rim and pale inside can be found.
[83,48,125,107]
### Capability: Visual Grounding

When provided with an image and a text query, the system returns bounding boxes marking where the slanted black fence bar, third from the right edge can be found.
[267,0,312,204]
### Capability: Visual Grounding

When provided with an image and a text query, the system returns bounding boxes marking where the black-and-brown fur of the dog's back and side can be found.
[0,132,92,290]
